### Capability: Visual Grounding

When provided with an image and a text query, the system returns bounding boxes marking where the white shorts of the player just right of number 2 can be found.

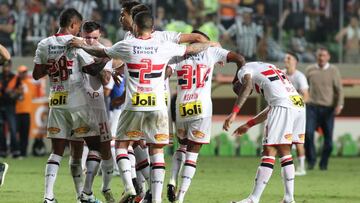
[176,117,211,144]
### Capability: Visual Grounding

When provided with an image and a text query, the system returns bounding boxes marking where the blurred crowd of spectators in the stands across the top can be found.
[0,0,360,63]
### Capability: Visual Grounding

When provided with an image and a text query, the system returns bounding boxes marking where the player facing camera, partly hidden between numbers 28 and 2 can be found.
[70,21,115,203]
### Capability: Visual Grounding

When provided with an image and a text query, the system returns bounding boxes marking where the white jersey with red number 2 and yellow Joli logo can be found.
[104,38,186,111]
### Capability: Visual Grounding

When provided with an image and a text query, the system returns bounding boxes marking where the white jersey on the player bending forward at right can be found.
[237,62,304,108]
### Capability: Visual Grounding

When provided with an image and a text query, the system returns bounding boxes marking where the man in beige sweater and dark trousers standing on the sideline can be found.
[305,48,344,170]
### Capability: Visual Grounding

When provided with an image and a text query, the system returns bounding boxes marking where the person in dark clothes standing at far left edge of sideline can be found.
[0,61,20,158]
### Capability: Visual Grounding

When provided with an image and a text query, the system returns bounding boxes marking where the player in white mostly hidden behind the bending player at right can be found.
[284,52,309,176]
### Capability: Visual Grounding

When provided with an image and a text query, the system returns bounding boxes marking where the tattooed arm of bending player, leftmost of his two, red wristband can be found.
[223,74,252,131]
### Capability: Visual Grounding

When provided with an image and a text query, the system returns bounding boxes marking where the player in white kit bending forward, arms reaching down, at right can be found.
[223,62,305,203]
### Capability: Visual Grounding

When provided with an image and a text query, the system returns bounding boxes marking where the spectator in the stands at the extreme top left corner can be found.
[0,3,15,55]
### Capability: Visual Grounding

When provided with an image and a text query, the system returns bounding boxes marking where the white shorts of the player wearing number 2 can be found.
[116,110,169,144]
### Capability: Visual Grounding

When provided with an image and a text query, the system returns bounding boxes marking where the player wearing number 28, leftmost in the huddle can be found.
[33,8,109,203]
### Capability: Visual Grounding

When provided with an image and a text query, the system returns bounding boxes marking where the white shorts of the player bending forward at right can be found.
[263,106,306,146]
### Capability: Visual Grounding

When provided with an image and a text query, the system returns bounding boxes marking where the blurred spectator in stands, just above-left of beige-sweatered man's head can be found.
[290,27,315,63]
